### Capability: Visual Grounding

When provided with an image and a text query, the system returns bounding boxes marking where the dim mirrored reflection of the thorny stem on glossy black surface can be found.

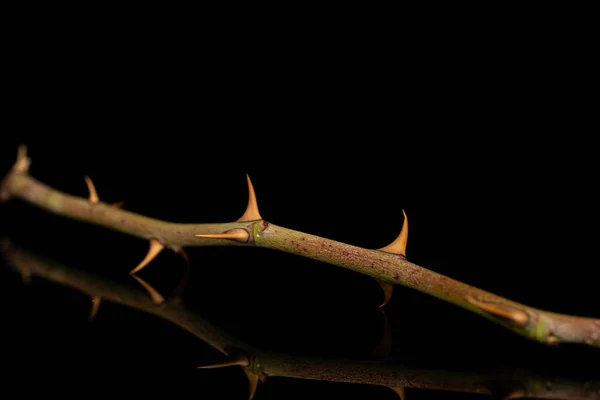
[2,241,600,399]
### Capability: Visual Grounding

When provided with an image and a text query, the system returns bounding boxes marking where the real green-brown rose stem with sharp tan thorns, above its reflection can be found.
[0,146,600,347]
